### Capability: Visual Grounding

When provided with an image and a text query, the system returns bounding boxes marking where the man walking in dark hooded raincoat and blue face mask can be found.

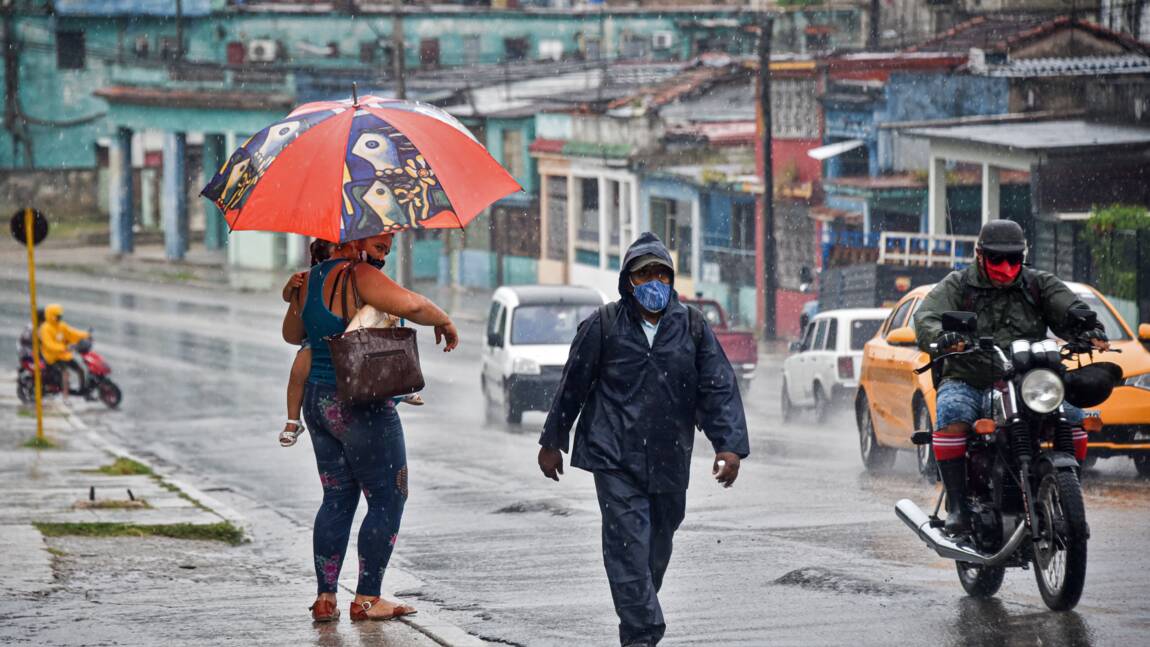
[539,232,750,647]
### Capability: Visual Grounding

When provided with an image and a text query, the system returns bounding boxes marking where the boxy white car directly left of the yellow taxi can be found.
[781,308,890,422]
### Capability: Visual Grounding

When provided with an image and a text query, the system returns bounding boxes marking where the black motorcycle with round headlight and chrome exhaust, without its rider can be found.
[895,310,1122,610]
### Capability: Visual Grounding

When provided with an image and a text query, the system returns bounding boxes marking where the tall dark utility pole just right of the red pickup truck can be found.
[759,14,779,341]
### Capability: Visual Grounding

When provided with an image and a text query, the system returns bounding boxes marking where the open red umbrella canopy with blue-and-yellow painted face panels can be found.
[200,95,521,242]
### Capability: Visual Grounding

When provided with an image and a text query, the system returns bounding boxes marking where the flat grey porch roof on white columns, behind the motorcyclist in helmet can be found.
[903,120,1150,152]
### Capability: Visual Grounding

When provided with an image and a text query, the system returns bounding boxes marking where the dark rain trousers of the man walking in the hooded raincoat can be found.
[595,471,687,645]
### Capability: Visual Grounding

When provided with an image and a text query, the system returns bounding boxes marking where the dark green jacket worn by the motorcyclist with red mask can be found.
[914,265,1087,388]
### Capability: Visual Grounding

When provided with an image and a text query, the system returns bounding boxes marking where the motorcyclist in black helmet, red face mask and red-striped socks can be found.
[914,219,1110,534]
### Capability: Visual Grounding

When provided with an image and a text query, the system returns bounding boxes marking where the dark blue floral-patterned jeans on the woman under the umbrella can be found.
[304,383,407,595]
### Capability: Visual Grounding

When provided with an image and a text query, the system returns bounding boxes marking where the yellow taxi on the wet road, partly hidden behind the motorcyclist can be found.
[854,283,1150,479]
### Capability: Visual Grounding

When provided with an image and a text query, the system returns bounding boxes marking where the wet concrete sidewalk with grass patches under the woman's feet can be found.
[0,378,485,647]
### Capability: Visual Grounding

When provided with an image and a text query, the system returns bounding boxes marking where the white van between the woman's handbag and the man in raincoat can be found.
[483,285,606,424]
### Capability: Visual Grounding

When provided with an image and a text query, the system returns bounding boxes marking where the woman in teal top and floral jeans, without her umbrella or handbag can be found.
[283,234,459,622]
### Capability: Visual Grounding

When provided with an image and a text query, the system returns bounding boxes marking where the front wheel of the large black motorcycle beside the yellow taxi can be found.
[1034,470,1089,611]
